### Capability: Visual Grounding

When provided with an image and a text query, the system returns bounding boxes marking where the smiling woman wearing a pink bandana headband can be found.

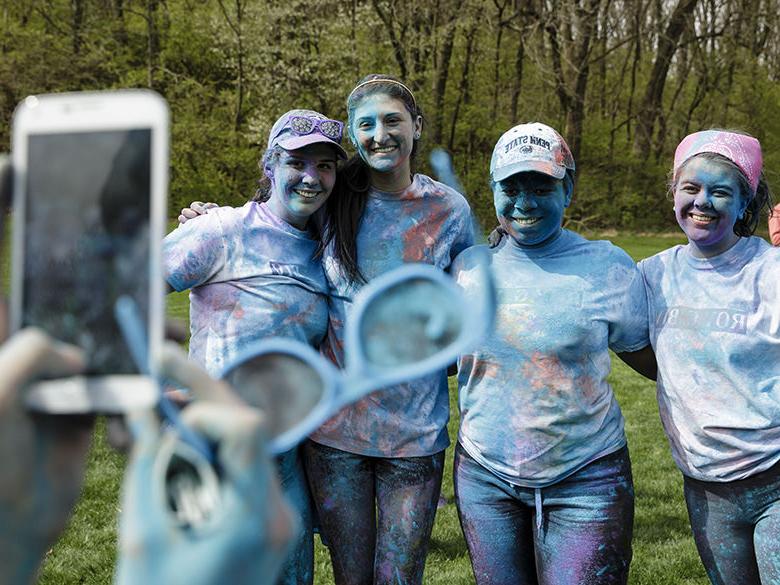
[639,130,780,585]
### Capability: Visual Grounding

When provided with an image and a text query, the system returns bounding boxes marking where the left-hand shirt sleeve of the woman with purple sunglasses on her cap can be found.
[163,210,227,291]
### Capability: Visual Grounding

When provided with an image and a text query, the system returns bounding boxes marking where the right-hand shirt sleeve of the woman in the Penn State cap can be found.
[606,250,650,353]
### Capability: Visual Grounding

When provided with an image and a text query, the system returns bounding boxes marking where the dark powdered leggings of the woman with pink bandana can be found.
[684,464,780,585]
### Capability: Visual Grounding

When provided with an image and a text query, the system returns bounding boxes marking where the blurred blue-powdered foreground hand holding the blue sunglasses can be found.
[116,344,297,585]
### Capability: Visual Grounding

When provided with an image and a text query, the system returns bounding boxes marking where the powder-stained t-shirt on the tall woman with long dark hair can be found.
[311,175,474,457]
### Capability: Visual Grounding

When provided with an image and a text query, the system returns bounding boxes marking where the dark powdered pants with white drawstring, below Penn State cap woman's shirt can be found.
[455,443,634,585]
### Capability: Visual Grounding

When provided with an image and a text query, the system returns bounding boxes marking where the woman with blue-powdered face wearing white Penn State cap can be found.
[452,123,654,585]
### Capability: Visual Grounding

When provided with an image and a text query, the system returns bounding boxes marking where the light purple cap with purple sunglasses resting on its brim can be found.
[268,110,347,159]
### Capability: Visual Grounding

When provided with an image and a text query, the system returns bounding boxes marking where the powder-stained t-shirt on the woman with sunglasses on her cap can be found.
[163,202,328,376]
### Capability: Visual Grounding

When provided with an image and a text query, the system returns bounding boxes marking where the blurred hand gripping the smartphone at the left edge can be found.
[0,329,94,584]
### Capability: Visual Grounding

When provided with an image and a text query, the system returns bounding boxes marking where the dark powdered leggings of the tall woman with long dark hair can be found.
[304,441,444,585]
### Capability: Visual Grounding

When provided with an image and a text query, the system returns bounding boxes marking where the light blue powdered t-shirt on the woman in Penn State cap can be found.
[452,230,649,488]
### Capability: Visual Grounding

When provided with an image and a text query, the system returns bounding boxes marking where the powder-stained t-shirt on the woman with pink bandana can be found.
[639,237,780,481]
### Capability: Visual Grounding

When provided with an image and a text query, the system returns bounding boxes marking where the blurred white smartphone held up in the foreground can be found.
[11,90,169,414]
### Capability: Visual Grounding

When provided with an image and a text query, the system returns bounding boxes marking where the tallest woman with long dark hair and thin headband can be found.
[304,75,473,585]
